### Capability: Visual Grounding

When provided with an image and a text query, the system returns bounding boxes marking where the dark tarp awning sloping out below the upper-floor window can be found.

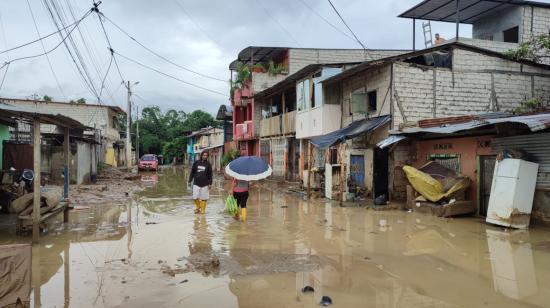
[310,115,391,149]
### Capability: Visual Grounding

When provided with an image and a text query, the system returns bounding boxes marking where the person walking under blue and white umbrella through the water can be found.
[225,156,272,221]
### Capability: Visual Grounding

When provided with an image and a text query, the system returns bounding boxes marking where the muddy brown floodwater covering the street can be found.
[0,169,550,307]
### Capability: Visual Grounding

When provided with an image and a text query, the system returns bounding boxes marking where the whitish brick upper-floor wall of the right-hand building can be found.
[394,49,550,125]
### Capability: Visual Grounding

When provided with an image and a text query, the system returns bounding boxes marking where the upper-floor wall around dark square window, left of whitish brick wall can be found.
[341,64,391,127]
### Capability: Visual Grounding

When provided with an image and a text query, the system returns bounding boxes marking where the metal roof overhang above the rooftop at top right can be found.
[399,0,550,24]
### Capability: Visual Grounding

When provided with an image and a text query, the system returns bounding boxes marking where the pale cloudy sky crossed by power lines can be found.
[0,0,536,112]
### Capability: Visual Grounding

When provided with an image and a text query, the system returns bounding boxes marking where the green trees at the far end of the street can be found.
[133,106,221,162]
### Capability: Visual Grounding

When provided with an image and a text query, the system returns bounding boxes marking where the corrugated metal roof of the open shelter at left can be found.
[0,102,88,129]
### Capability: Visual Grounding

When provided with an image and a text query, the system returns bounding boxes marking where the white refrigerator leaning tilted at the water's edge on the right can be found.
[486,159,539,229]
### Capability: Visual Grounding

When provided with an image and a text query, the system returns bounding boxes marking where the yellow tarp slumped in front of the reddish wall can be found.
[403,166,470,202]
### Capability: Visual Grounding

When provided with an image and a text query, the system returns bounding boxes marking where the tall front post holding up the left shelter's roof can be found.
[32,118,40,244]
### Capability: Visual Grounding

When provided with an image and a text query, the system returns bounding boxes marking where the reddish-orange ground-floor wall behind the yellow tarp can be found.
[413,136,493,204]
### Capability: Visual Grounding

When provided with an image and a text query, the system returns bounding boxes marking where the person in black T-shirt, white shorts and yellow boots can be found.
[189,152,212,214]
